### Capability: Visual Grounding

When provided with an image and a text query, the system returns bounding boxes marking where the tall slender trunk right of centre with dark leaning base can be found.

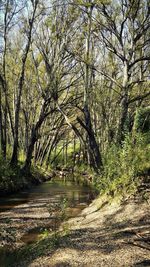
[81,0,102,171]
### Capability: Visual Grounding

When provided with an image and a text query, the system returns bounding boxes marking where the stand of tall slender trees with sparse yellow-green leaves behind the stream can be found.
[0,0,150,175]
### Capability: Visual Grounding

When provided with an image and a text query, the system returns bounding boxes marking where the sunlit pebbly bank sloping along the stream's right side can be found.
[0,180,150,267]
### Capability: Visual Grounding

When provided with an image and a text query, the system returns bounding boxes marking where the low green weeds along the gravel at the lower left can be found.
[0,198,69,266]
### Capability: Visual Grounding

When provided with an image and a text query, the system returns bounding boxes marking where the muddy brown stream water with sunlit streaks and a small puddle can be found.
[0,179,96,244]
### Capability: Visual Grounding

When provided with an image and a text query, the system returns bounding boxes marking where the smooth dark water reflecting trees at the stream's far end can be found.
[0,180,95,215]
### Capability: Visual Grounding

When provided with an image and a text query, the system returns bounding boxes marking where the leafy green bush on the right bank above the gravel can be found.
[95,134,150,199]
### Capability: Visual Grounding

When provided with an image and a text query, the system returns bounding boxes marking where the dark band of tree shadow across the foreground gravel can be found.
[0,209,150,267]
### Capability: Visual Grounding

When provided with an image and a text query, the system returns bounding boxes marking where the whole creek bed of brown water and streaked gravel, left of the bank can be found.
[0,177,96,266]
